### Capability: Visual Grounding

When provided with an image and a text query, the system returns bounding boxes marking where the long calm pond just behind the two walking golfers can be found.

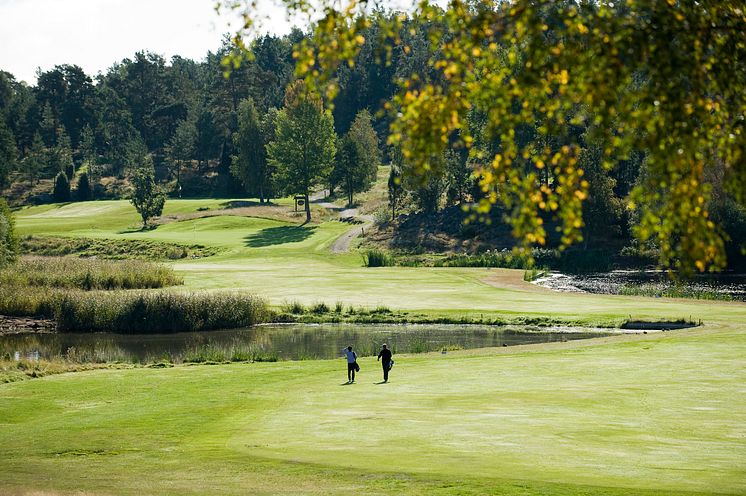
[0,324,619,363]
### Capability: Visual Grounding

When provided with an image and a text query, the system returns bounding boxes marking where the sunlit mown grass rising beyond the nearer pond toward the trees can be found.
[11,200,746,321]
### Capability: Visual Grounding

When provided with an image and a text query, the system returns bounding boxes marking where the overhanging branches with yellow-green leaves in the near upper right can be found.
[222,0,746,273]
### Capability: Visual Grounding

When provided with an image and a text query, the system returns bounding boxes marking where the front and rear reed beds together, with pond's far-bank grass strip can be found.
[0,257,693,334]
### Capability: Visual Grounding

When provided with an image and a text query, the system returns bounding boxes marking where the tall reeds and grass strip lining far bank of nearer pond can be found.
[0,294,702,335]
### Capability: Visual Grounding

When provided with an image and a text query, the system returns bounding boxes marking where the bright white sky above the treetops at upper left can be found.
[0,0,296,84]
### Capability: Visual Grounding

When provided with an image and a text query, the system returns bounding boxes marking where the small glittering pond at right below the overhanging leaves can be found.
[535,270,746,301]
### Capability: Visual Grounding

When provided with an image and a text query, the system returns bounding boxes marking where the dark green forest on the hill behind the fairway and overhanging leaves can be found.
[0,6,746,272]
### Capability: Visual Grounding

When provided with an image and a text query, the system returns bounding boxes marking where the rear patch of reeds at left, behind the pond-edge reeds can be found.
[0,257,184,290]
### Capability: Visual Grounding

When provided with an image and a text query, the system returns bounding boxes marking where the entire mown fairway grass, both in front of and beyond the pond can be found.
[0,200,746,495]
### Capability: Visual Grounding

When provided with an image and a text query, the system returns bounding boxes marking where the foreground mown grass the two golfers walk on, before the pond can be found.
[0,325,746,495]
